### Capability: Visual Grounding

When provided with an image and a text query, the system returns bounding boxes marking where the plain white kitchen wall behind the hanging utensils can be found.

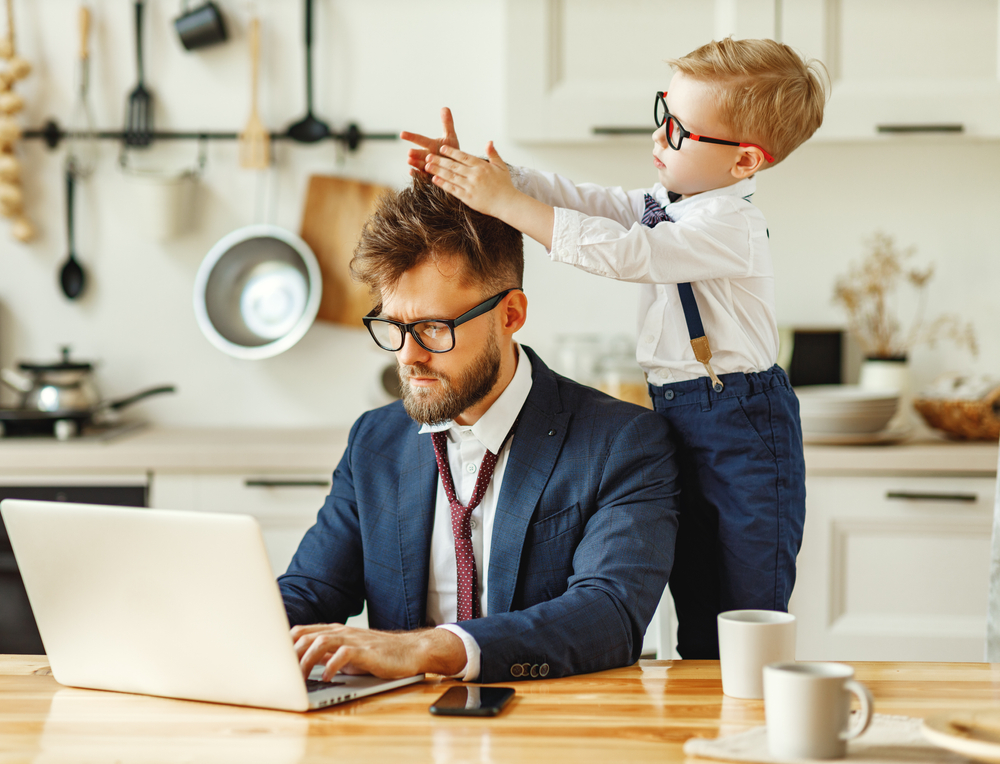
[0,0,1000,426]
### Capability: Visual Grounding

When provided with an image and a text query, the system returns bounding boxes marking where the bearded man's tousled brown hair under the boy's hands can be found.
[351,175,524,300]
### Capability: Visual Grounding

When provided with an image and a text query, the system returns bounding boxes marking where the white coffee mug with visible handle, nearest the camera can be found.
[764,663,875,759]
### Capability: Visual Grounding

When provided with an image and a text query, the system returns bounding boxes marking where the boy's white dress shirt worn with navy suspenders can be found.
[510,167,778,385]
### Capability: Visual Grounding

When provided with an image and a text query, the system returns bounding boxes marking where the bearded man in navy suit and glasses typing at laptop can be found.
[279,178,677,682]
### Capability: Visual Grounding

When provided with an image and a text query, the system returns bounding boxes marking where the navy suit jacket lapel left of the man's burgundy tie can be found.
[396,426,438,629]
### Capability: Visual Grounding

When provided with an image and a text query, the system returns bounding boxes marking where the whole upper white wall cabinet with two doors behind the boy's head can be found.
[505,0,1000,142]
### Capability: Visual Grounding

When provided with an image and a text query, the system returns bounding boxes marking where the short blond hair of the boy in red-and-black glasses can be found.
[667,37,829,167]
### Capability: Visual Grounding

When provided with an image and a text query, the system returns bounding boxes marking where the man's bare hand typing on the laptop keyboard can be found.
[292,623,466,681]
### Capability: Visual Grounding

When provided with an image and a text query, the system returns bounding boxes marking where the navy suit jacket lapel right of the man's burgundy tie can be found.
[488,345,572,614]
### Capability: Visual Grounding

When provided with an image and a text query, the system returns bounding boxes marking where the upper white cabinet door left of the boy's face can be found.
[506,0,775,141]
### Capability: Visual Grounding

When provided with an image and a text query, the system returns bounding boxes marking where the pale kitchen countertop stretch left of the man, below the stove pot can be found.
[0,427,349,475]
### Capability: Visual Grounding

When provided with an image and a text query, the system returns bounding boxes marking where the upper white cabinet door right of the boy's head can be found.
[779,0,1000,139]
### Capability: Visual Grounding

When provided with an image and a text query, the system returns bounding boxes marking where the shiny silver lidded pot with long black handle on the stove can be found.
[0,347,175,436]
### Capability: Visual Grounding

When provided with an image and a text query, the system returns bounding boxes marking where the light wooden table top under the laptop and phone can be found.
[0,656,1000,764]
